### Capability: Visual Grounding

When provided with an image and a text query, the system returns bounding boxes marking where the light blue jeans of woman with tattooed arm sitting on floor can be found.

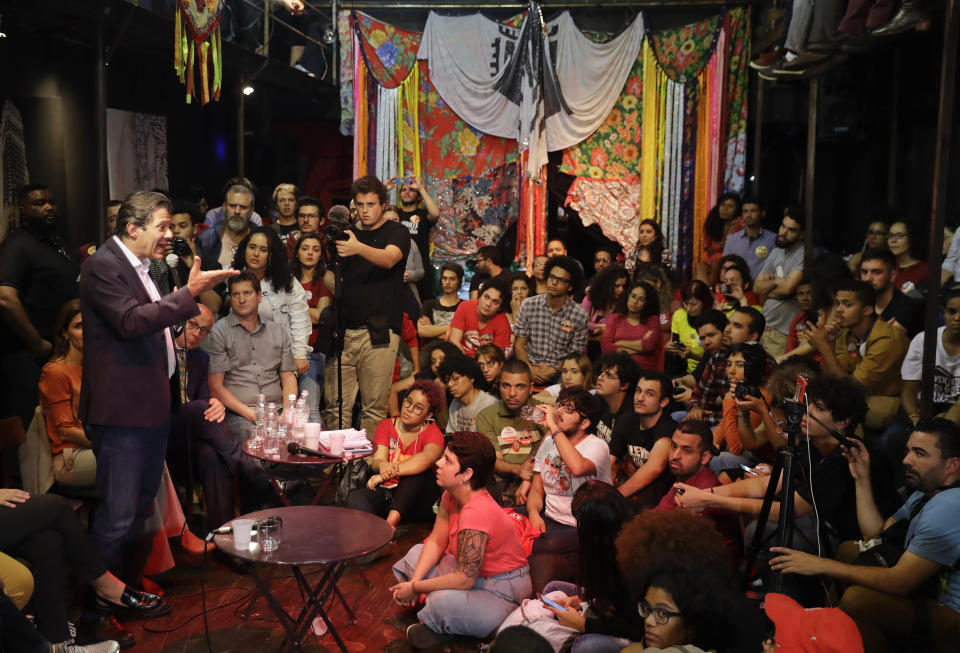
[393,544,532,638]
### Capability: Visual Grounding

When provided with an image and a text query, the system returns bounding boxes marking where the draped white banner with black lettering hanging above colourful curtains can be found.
[417,2,643,177]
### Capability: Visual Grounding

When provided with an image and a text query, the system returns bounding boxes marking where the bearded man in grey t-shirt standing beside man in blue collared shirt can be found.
[753,207,804,358]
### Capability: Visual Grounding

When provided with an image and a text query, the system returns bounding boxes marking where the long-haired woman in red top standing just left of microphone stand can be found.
[290,233,333,422]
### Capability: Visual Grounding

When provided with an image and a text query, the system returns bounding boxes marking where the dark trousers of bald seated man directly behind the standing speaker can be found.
[167,400,273,529]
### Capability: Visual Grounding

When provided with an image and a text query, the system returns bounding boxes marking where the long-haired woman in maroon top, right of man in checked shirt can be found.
[600,281,663,370]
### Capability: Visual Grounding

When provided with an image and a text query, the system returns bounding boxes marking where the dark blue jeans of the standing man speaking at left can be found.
[85,418,170,582]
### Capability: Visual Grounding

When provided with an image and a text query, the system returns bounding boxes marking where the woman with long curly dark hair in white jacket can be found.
[230,227,313,375]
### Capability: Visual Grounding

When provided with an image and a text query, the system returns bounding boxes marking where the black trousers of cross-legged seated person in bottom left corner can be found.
[0,494,107,636]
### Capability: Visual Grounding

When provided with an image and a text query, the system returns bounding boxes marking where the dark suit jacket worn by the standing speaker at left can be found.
[80,238,200,428]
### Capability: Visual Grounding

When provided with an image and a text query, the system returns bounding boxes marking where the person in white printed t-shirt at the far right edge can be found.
[900,289,960,424]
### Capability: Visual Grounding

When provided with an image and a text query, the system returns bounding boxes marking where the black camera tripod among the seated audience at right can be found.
[742,401,805,592]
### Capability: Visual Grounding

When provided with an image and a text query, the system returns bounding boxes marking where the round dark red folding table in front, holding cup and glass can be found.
[215,506,394,653]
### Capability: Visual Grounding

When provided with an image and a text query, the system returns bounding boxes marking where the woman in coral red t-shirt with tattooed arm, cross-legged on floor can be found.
[390,431,533,649]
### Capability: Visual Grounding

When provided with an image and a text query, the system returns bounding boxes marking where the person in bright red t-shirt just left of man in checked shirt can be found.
[450,279,512,358]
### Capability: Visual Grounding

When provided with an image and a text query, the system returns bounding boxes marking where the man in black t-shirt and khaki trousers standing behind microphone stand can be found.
[324,176,410,433]
